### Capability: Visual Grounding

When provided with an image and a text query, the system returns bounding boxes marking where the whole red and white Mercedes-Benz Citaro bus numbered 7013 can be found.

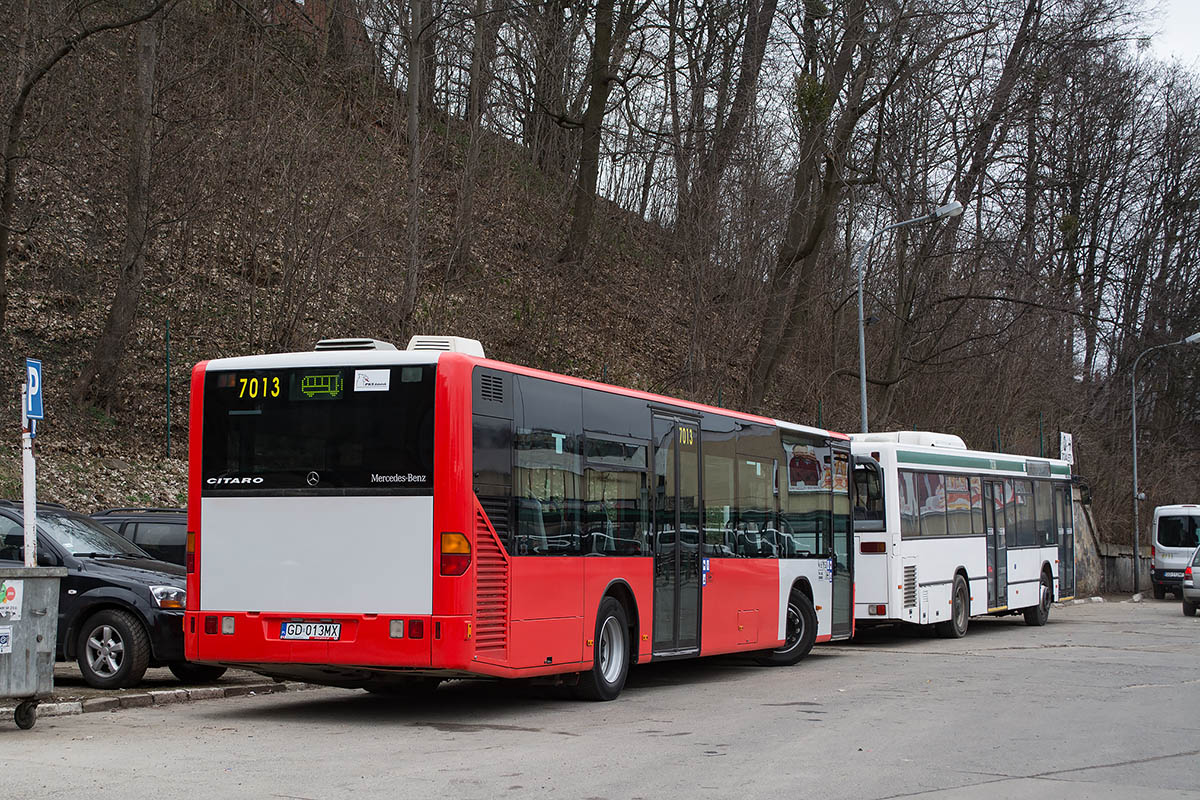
[185,337,853,699]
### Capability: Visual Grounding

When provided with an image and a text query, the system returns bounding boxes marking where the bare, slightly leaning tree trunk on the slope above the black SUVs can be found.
[76,19,158,409]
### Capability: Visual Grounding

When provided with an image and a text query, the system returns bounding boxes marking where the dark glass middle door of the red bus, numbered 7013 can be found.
[654,416,701,656]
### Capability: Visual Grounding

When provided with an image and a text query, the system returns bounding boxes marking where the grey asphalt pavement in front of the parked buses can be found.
[0,601,1200,800]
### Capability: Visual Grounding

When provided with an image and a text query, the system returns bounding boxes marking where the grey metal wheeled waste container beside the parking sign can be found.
[0,567,67,729]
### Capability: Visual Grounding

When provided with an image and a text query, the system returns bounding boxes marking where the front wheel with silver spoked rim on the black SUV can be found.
[76,608,150,688]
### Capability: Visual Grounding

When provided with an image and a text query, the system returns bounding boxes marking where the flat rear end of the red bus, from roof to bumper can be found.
[185,339,453,686]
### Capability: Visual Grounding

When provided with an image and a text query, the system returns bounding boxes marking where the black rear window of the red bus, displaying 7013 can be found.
[202,365,434,494]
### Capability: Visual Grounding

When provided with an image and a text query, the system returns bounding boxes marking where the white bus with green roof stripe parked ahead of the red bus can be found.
[851,431,1075,638]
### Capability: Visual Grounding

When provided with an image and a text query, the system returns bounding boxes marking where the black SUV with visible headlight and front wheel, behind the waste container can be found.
[0,500,224,688]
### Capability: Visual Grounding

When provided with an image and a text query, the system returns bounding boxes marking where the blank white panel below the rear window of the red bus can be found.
[198,497,433,614]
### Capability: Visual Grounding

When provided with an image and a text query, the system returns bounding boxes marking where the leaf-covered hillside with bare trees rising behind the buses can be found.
[0,0,1200,541]
